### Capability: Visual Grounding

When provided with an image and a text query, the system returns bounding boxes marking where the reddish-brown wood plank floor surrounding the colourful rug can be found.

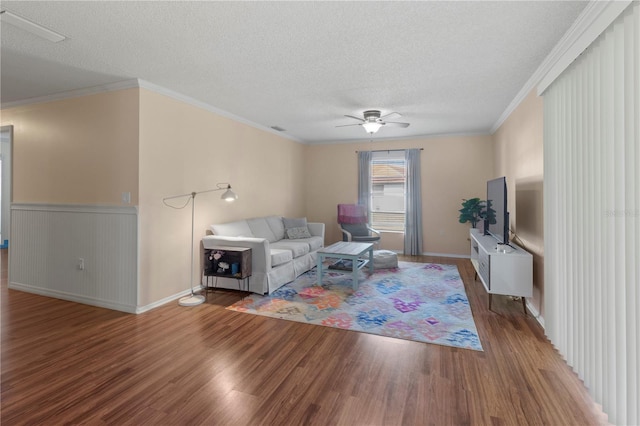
[0,250,606,426]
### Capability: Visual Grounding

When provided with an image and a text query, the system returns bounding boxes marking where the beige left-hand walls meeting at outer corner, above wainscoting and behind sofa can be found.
[1,89,306,306]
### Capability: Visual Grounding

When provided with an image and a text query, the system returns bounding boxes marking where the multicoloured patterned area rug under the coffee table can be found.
[227,262,482,351]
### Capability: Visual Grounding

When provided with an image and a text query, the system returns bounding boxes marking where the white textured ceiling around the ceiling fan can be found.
[0,1,587,143]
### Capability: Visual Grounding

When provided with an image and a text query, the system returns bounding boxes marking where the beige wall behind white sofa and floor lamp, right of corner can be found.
[139,90,306,305]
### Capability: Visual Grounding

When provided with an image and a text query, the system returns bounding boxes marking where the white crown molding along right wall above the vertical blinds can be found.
[491,0,632,134]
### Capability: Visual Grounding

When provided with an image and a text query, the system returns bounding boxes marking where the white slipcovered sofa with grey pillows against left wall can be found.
[202,216,324,294]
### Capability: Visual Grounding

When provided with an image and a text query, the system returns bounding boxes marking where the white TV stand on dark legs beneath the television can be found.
[470,229,533,315]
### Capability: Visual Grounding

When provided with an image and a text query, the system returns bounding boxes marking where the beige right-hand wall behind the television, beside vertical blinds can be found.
[493,90,544,317]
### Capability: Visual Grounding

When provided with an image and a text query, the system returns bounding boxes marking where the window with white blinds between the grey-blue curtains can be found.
[369,151,407,232]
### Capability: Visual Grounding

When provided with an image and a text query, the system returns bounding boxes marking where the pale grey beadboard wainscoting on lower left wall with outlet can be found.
[9,204,138,313]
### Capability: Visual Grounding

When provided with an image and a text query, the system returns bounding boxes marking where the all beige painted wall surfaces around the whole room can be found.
[0,84,543,307]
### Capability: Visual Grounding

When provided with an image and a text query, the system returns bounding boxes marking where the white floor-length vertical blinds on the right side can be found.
[544,1,640,424]
